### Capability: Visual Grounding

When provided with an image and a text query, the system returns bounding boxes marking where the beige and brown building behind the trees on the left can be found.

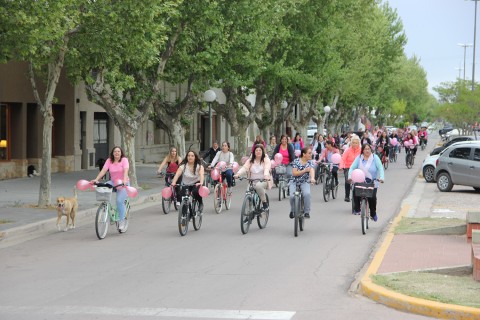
[0,62,262,180]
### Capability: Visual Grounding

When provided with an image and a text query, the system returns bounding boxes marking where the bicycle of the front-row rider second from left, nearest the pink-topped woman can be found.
[178,184,203,237]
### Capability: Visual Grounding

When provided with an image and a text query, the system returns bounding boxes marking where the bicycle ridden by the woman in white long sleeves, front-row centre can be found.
[239,178,270,234]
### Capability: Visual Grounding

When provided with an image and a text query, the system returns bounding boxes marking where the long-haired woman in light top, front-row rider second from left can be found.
[172,150,205,213]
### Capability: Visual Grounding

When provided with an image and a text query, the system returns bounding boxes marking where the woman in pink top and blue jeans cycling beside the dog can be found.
[90,147,130,232]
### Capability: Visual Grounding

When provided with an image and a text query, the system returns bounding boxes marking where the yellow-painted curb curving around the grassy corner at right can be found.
[359,205,480,320]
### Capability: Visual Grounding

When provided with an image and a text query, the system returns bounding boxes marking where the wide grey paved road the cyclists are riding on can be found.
[0,146,436,320]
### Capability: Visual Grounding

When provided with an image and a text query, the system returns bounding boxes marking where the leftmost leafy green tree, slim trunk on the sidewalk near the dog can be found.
[0,0,84,207]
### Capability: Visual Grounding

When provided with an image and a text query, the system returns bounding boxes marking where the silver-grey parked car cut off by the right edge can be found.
[435,141,480,192]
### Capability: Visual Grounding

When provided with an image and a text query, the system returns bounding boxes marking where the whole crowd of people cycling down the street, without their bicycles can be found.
[91,128,428,235]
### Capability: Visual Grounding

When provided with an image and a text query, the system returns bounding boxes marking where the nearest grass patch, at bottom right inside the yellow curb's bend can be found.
[372,272,480,308]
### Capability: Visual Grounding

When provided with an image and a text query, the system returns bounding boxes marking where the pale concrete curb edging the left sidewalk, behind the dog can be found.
[0,193,162,249]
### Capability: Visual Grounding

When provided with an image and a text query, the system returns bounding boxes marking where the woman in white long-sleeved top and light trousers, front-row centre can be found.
[234,144,272,210]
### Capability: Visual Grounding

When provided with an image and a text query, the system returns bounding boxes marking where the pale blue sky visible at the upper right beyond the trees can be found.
[385,0,480,96]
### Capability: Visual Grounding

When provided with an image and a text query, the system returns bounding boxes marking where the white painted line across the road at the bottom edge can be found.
[0,306,295,320]
